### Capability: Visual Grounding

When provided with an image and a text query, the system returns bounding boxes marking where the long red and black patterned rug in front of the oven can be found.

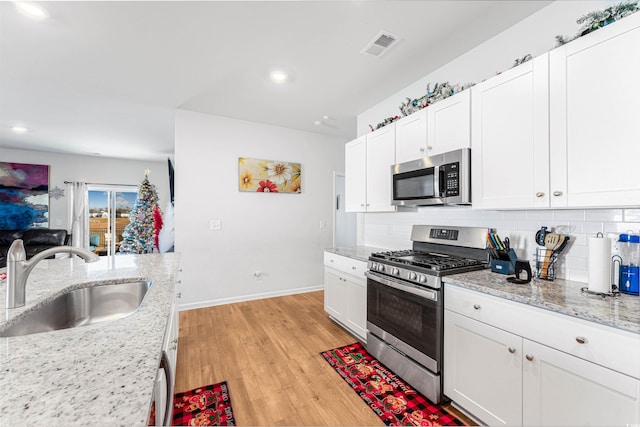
[320,343,464,426]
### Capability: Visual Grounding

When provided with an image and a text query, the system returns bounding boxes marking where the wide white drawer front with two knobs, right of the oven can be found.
[444,285,640,379]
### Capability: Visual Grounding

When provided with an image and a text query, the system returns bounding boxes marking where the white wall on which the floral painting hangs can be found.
[175,110,344,309]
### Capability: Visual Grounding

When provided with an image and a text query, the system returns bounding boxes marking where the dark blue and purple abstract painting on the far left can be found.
[0,162,49,230]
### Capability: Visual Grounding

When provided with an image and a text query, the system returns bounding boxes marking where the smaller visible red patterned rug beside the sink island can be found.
[172,381,236,426]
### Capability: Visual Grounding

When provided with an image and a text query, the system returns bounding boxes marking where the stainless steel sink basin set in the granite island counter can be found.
[0,280,151,337]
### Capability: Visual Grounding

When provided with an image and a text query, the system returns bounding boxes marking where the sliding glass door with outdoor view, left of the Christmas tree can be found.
[87,185,138,256]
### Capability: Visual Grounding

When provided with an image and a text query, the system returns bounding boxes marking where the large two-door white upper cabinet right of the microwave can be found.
[471,14,640,209]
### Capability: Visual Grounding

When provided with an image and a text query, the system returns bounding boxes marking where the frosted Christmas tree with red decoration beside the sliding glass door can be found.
[120,169,162,254]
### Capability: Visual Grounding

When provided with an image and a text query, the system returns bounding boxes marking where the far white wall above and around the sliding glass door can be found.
[0,148,169,230]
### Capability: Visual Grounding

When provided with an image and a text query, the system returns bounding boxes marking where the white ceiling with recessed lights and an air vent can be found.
[0,0,550,160]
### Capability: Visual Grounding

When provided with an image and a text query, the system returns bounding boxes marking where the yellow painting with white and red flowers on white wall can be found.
[238,157,302,193]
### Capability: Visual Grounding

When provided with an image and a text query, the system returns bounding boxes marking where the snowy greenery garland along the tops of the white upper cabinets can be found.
[369,0,640,132]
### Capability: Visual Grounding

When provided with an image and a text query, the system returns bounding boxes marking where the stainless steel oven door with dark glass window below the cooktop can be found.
[365,271,443,374]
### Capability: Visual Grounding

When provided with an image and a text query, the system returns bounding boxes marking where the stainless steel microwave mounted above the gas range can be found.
[391,148,471,206]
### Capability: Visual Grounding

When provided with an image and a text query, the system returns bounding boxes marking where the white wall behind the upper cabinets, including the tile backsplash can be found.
[357,1,640,282]
